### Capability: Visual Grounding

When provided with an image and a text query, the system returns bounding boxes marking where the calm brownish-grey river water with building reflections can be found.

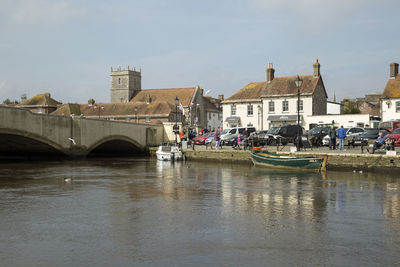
[0,159,400,266]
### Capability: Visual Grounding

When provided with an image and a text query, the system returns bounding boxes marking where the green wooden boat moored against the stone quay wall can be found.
[251,150,328,171]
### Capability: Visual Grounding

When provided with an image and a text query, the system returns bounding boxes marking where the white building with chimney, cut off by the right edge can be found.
[381,63,400,121]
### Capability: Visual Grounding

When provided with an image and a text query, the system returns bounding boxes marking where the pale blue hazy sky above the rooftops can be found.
[0,0,400,103]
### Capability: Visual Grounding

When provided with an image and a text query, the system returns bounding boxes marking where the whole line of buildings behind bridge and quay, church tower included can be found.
[5,59,400,140]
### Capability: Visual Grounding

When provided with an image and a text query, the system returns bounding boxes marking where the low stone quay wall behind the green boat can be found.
[150,146,400,171]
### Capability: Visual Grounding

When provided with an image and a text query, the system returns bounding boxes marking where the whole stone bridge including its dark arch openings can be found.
[0,106,166,157]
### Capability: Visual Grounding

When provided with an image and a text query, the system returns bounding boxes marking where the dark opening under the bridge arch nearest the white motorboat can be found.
[87,135,145,156]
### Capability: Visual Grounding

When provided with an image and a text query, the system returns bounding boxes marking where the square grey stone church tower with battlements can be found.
[110,66,142,103]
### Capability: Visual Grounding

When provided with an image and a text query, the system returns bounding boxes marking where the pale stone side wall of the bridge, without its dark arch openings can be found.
[0,106,164,156]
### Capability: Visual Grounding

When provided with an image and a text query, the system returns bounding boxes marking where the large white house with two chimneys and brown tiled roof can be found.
[222,60,328,132]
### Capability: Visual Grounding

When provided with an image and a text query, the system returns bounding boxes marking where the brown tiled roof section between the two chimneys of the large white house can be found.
[261,75,321,97]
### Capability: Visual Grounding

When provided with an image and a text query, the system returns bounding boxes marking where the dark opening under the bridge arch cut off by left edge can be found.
[0,129,69,156]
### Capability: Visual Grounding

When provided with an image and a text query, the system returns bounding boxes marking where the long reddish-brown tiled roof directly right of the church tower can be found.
[130,87,196,107]
